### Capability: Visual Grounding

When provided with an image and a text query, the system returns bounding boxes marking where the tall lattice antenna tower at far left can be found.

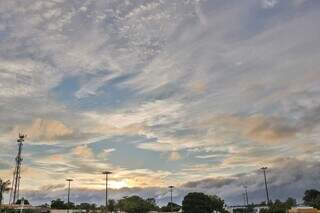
[9,133,27,204]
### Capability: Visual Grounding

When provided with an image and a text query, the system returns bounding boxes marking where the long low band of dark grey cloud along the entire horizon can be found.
[16,158,320,205]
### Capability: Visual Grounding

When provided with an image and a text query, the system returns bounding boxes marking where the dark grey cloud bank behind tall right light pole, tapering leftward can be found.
[182,158,320,203]
